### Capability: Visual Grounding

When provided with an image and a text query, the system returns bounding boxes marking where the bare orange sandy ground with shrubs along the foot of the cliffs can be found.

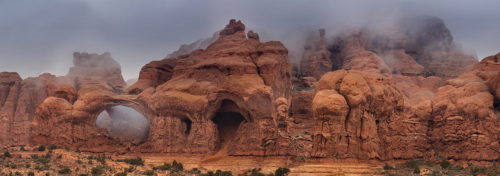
[0,146,383,176]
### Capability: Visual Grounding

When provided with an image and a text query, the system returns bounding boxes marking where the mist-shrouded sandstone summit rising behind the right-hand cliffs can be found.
[300,17,477,80]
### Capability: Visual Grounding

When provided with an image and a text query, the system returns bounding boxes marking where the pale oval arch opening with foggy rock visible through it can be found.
[96,105,150,143]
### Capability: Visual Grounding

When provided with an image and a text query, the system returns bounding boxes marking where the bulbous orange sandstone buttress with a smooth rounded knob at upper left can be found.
[312,70,403,159]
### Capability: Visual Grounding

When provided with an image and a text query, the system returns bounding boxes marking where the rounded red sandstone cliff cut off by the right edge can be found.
[430,53,500,161]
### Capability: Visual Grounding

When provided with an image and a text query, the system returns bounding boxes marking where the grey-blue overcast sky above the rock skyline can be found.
[0,0,500,79]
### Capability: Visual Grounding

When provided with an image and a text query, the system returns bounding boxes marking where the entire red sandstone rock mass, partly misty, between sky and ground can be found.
[0,17,500,161]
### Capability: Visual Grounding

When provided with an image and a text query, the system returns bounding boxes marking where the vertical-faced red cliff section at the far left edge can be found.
[0,72,56,145]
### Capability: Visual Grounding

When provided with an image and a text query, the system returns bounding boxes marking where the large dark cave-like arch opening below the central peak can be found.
[212,100,247,150]
